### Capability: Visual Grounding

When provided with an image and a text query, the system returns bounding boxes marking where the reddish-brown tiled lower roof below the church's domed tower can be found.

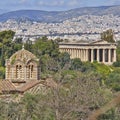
[0,79,57,93]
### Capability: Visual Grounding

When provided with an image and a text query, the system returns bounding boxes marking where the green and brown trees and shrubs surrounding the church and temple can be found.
[0,31,120,120]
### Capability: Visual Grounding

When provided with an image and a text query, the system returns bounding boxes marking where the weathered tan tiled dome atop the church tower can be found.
[9,48,38,64]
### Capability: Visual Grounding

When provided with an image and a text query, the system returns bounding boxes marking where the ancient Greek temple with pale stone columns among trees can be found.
[59,40,116,65]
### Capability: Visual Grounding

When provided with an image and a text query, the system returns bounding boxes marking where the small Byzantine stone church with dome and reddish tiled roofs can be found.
[0,46,54,95]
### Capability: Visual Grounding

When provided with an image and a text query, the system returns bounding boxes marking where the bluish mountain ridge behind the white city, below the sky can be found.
[0,6,120,22]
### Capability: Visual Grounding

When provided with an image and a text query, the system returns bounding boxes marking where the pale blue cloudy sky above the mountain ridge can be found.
[0,0,120,11]
